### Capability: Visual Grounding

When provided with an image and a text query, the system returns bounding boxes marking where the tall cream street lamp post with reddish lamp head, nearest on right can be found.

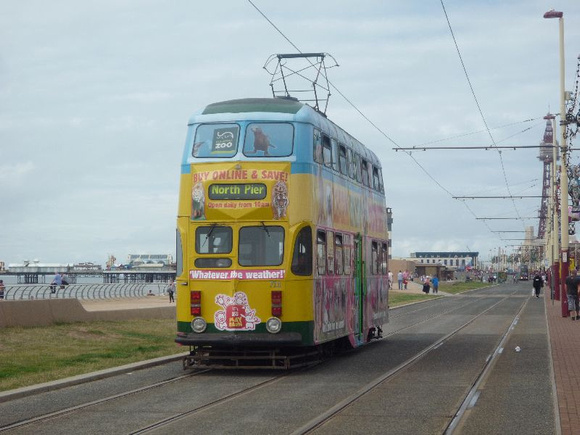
[544,9,569,317]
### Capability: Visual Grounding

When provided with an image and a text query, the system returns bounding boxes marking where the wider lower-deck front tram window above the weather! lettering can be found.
[238,225,284,266]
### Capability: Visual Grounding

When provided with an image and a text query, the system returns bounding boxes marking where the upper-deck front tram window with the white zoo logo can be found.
[191,124,240,158]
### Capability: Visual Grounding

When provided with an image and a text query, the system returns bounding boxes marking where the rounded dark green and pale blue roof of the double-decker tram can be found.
[189,98,381,167]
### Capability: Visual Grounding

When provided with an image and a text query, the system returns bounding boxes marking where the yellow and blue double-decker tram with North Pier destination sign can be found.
[175,98,388,368]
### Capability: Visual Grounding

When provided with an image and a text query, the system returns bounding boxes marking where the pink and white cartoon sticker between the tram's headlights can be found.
[214,292,261,331]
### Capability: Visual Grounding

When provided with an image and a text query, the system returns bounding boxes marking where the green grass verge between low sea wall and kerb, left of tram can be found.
[0,319,185,391]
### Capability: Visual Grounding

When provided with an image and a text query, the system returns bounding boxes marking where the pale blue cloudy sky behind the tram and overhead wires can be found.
[0,0,580,264]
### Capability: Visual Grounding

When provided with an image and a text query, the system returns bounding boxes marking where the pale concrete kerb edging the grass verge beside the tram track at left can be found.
[0,353,189,403]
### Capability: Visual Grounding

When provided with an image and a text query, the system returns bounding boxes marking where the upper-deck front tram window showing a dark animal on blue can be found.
[244,122,294,157]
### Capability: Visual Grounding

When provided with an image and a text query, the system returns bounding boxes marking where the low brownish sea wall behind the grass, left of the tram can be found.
[0,299,175,327]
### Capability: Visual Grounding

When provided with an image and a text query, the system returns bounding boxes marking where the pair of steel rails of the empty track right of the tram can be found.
[292,291,530,435]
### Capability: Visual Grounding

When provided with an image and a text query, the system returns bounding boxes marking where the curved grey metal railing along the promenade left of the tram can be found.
[4,282,167,300]
